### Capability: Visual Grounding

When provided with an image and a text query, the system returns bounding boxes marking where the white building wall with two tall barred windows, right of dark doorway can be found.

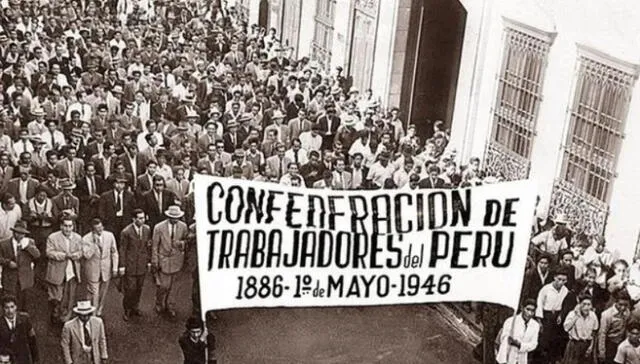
[452,0,640,260]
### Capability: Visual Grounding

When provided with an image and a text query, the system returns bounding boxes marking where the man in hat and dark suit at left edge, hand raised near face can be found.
[0,220,40,309]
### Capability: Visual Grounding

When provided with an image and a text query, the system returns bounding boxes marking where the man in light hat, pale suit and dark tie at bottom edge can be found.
[60,301,109,364]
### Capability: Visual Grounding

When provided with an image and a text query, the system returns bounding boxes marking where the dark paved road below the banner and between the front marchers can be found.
[29,275,473,364]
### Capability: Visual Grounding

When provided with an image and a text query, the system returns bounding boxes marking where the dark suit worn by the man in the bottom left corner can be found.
[0,312,39,364]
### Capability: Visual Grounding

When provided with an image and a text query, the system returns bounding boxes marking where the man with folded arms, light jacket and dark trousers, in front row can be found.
[45,216,82,323]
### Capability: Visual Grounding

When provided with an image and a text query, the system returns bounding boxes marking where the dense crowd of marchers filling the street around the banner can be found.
[0,0,640,364]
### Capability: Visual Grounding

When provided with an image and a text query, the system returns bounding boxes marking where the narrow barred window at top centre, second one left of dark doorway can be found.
[311,0,336,70]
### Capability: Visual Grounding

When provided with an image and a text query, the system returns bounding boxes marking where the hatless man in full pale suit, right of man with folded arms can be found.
[82,219,119,316]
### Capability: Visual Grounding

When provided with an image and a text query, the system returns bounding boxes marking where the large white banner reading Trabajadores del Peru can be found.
[195,175,536,312]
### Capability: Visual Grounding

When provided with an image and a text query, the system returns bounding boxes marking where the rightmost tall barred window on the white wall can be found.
[561,47,637,203]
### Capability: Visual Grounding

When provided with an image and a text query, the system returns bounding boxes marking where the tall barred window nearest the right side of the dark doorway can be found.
[491,21,552,160]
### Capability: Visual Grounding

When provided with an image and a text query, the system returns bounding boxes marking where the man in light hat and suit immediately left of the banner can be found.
[151,205,189,318]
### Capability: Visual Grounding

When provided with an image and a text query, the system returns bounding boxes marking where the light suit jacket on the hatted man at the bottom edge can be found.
[60,316,109,364]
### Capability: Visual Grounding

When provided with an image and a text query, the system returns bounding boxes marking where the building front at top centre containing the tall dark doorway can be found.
[236,0,466,141]
